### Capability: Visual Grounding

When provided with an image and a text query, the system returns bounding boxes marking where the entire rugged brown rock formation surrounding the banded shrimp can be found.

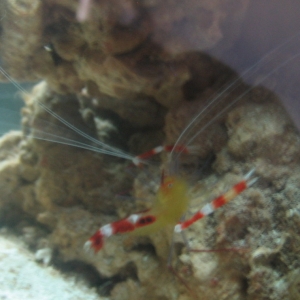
[0,0,300,300]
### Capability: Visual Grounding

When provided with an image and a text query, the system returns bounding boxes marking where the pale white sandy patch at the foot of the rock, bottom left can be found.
[0,236,105,300]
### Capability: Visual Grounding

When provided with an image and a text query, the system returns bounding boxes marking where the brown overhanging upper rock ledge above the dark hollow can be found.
[1,0,249,106]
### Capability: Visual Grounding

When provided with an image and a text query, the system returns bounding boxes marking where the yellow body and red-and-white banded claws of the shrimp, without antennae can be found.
[84,152,257,252]
